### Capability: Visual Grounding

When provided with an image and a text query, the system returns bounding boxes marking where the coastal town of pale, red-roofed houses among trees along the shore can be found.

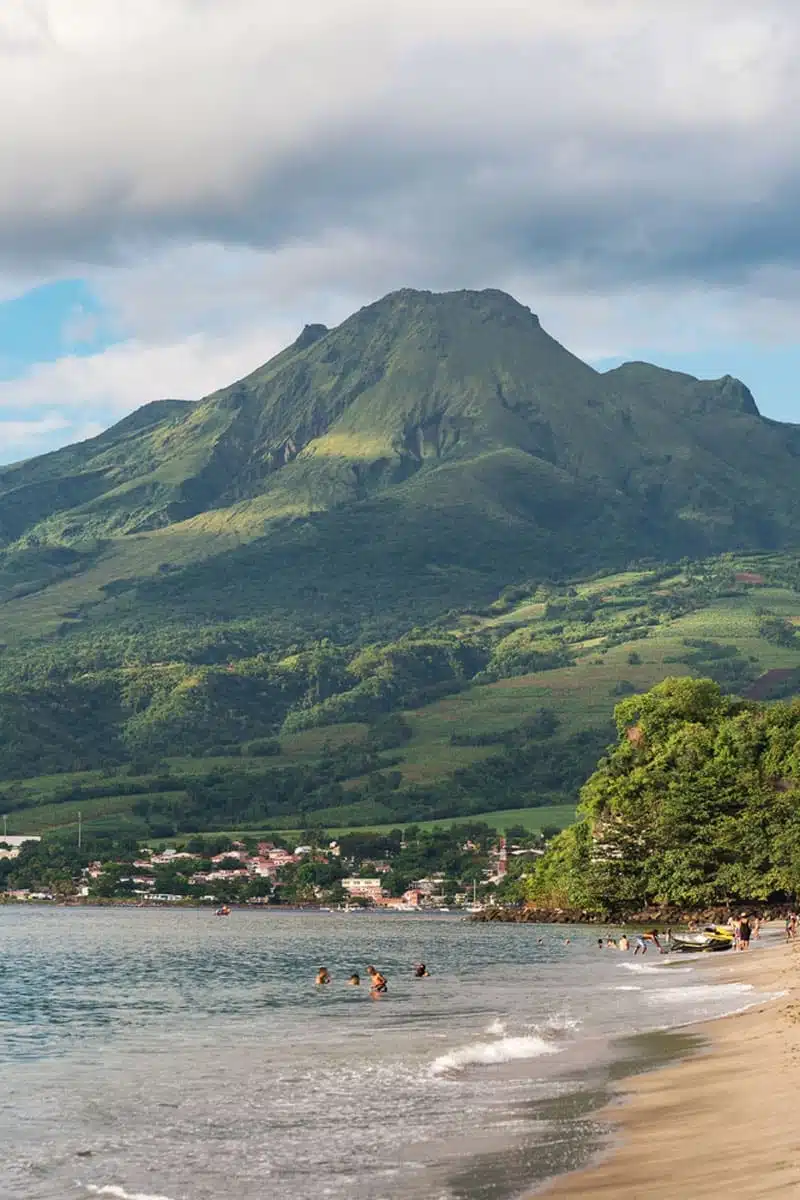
[0,822,546,912]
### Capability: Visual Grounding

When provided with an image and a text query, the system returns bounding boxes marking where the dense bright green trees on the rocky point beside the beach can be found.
[530,679,800,910]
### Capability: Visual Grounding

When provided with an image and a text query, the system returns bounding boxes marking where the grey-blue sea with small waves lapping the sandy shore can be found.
[0,905,777,1200]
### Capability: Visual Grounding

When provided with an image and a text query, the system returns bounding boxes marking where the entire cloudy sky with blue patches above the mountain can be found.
[0,0,800,462]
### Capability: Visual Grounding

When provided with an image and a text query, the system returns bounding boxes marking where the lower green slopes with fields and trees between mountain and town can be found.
[0,556,800,838]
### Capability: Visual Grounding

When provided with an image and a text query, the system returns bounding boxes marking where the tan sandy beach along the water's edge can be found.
[540,943,800,1200]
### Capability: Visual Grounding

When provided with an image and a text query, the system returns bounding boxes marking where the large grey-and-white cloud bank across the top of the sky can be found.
[0,0,800,287]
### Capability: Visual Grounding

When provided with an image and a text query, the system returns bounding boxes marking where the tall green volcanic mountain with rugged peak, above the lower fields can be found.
[0,289,800,644]
